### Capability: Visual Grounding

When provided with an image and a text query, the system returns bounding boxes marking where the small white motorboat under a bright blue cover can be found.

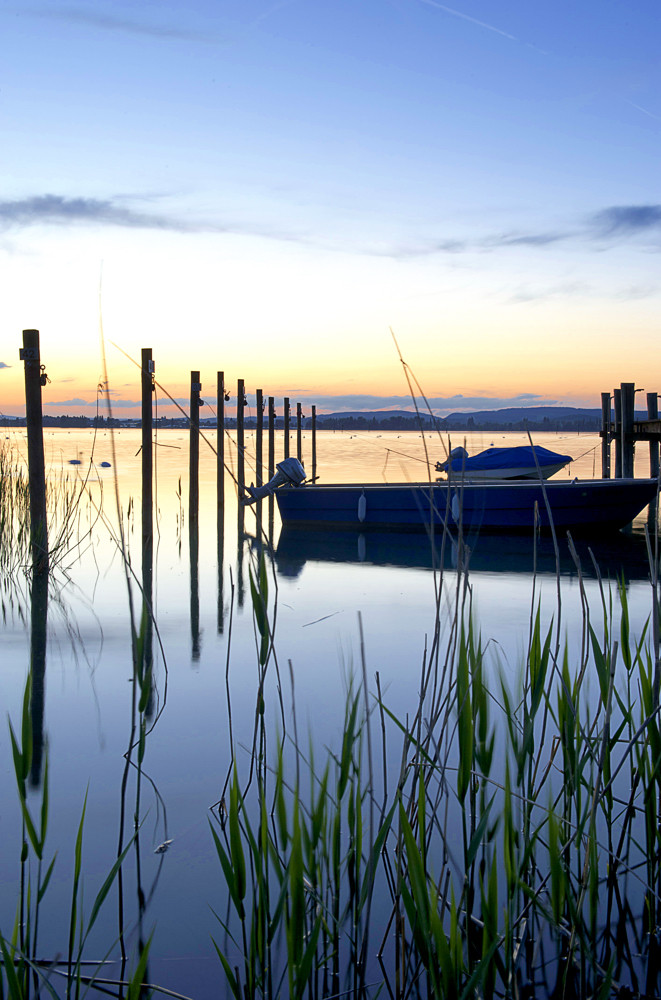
[436,445,571,482]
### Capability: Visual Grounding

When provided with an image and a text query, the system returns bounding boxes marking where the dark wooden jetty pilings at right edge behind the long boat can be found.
[599,382,661,479]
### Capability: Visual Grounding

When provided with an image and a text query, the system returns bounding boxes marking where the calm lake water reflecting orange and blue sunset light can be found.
[0,430,651,998]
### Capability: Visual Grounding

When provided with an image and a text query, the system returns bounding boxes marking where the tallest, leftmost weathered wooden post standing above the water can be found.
[19,330,48,572]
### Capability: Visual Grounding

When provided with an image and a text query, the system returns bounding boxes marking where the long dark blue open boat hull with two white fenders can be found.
[275,479,657,533]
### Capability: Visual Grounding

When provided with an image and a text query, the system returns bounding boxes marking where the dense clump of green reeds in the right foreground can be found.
[212,536,661,1000]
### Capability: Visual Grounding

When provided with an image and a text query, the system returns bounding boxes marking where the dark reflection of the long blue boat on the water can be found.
[275,527,650,582]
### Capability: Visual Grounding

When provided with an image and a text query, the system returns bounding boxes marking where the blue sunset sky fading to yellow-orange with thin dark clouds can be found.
[0,0,661,416]
